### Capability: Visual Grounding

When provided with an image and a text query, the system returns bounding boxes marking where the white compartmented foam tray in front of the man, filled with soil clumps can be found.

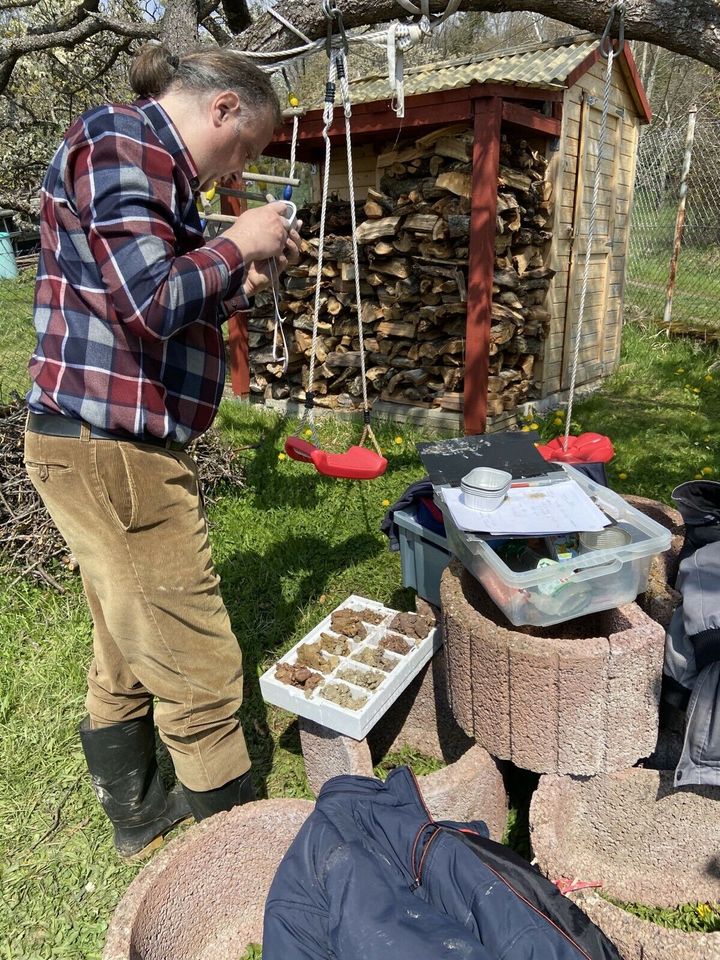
[260,594,442,740]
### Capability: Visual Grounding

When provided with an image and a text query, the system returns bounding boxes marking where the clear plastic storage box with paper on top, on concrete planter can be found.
[435,464,671,627]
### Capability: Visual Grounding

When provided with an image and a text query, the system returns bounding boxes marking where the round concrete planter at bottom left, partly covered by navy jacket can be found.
[103,800,314,960]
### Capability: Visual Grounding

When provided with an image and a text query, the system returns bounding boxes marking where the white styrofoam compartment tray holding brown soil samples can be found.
[260,594,441,740]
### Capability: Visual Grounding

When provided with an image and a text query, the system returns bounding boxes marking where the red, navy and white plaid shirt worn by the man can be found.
[27,100,248,443]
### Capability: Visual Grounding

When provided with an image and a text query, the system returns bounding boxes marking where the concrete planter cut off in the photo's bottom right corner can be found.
[571,892,720,960]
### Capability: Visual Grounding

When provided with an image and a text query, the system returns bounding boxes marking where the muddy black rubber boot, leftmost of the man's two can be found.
[80,716,191,860]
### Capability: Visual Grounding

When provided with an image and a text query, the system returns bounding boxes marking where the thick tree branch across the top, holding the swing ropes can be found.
[232,0,720,69]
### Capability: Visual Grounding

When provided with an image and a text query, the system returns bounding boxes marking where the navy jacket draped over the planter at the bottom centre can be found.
[263,767,620,960]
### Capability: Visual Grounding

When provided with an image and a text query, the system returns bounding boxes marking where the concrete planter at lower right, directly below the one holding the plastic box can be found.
[530,768,720,908]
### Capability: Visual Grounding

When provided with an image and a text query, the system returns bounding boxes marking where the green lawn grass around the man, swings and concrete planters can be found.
[0,294,720,960]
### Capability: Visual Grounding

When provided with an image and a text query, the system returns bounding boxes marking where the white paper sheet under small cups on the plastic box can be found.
[442,480,611,536]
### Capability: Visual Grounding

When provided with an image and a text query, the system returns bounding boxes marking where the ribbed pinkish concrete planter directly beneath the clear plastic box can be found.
[440,562,665,775]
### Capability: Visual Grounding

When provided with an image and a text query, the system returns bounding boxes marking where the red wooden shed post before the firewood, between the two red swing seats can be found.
[463,97,502,433]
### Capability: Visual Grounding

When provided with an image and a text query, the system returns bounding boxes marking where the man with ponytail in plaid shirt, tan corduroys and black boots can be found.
[25,46,299,857]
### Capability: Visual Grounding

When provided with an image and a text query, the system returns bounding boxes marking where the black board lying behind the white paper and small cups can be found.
[416,430,560,487]
